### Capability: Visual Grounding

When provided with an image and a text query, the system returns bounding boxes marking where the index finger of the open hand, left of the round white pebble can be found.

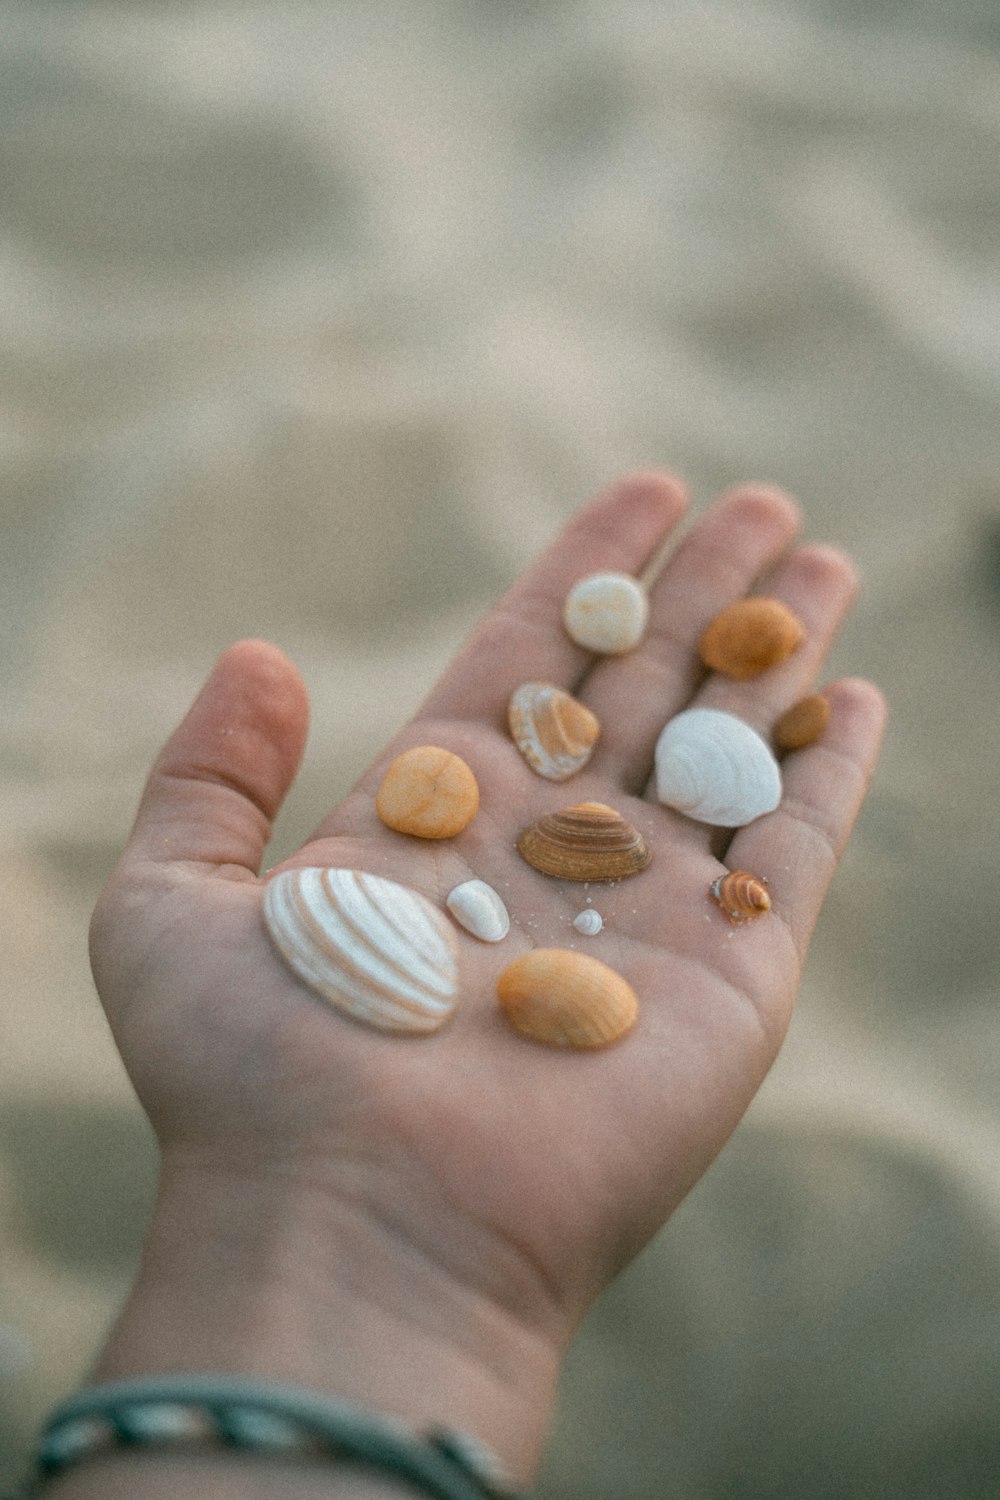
[417,471,687,720]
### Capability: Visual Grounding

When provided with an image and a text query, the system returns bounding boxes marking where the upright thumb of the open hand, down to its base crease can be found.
[123,641,309,875]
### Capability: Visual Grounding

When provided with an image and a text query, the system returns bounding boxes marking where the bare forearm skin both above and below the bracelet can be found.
[39,1173,558,1500]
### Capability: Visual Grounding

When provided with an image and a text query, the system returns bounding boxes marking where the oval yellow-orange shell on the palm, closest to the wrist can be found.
[496,948,639,1050]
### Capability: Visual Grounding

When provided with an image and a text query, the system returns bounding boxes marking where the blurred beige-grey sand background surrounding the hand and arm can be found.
[0,0,1000,1500]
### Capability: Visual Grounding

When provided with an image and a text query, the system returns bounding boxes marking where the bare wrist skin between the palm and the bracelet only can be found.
[79,1161,561,1485]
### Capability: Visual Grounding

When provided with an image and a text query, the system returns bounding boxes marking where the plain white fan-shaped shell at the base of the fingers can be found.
[655,708,781,828]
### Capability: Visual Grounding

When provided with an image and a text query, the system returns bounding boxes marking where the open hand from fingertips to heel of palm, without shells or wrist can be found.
[91,474,882,1344]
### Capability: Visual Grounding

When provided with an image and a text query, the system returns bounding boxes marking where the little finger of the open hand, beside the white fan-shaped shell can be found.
[726,678,886,956]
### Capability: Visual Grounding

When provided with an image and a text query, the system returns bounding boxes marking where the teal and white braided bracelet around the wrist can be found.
[17,1374,517,1500]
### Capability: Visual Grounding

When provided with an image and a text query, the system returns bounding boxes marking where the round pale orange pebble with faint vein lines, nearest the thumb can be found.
[375,746,480,839]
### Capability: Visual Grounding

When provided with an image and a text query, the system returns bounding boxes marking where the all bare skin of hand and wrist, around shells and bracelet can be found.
[48,473,883,1500]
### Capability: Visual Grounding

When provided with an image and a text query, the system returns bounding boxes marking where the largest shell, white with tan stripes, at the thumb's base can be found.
[264,867,459,1032]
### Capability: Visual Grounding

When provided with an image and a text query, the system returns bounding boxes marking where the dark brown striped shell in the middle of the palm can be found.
[517,803,652,881]
